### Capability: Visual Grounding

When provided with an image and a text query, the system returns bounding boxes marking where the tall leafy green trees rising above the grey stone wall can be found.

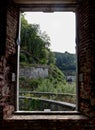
[20,14,55,64]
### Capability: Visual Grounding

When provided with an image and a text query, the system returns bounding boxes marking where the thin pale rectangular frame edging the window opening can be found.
[14,4,79,115]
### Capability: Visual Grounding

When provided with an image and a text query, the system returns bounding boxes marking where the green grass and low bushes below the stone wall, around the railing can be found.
[19,65,76,111]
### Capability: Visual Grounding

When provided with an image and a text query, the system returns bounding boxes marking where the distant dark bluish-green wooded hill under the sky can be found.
[55,52,76,75]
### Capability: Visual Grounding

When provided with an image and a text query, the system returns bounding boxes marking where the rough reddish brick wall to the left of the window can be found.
[0,1,18,118]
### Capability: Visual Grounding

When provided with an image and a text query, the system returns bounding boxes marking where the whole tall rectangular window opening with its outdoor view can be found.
[17,12,76,111]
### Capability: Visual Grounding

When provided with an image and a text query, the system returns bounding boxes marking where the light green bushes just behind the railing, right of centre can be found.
[35,79,76,94]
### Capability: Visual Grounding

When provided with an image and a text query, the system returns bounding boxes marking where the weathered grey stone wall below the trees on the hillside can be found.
[19,66,48,79]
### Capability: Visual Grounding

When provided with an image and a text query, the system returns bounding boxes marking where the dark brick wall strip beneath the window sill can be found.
[2,118,95,130]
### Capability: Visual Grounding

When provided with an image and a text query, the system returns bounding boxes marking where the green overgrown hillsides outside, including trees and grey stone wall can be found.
[19,15,76,111]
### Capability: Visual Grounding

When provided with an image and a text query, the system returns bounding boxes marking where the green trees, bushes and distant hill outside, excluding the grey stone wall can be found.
[19,14,76,110]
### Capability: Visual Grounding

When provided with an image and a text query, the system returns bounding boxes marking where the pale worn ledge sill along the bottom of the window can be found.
[6,111,88,120]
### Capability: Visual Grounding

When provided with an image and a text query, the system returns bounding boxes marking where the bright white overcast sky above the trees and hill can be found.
[25,12,75,53]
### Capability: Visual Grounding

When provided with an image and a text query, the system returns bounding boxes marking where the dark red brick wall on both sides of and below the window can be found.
[0,0,95,130]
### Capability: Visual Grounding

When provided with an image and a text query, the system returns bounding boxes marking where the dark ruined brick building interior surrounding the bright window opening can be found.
[0,0,95,130]
